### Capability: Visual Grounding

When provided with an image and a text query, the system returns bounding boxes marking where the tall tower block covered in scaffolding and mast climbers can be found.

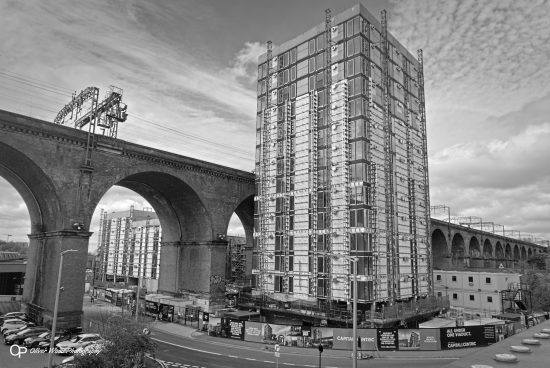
[252,4,431,322]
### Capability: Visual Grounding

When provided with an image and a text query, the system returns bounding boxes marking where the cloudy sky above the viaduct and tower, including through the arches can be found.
[0,0,550,249]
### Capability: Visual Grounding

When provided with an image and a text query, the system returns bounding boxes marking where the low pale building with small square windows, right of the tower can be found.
[434,270,521,319]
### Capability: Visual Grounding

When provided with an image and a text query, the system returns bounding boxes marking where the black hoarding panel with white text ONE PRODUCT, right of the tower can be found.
[441,325,497,349]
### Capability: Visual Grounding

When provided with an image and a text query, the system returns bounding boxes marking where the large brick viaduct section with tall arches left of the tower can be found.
[0,110,254,326]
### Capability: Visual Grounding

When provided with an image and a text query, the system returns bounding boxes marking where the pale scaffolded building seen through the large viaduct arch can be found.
[96,207,162,292]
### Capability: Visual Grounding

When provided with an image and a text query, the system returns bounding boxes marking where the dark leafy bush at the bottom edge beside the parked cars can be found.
[74,315,155,368]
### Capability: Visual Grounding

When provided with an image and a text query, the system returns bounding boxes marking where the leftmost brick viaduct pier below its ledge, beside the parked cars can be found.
[23,230,92,328]
